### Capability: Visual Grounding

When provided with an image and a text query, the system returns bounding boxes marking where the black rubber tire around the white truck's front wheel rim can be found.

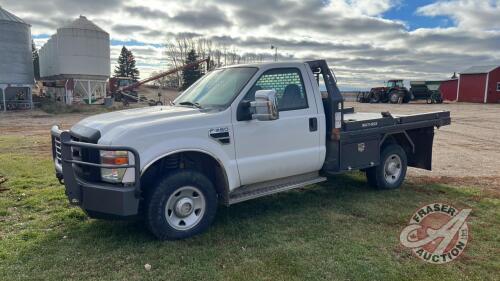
[145,170,217,240]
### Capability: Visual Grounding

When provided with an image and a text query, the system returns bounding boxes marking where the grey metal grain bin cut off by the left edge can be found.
[0,7,34,110]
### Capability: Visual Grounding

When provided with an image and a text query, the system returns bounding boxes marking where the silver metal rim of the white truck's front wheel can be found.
[165,186,206,230]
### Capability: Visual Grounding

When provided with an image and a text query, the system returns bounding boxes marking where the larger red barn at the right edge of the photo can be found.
[456,65,500,103]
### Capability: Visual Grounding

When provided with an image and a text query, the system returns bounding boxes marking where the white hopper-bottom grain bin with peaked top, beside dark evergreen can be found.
[40,16,111,104]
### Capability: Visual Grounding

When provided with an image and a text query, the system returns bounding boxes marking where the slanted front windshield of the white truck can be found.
[174,67,257,109]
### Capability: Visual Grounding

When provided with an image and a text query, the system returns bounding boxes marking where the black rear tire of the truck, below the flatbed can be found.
[366,144,408,189]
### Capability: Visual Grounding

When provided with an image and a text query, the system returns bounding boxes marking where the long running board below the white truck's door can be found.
[229,172,326,205]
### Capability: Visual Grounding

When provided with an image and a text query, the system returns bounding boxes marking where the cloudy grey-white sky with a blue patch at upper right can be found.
[0,0,500,89]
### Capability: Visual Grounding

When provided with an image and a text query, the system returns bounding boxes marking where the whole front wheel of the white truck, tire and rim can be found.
[145,170,217,240]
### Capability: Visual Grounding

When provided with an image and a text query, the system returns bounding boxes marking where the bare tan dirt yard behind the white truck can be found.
[0,100,500,188]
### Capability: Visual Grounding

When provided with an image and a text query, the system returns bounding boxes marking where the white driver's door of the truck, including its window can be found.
[233,67,321,185]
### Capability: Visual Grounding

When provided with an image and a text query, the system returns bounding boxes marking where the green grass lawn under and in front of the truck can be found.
[0,133,500,281]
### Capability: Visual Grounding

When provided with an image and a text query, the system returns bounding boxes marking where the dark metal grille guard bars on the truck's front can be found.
[51,126,141,204]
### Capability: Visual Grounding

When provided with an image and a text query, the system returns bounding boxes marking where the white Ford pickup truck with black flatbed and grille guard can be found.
[51,60,451,239]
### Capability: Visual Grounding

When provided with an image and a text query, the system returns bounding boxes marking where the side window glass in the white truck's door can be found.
[245,68,307,111]
